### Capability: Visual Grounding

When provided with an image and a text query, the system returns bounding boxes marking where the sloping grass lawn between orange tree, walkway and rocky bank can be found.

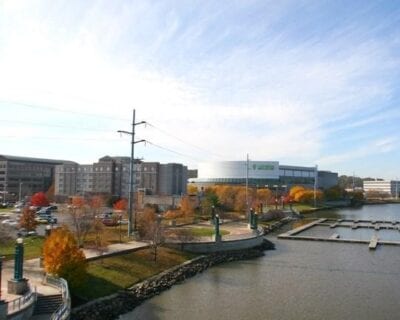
[73,247,195,300]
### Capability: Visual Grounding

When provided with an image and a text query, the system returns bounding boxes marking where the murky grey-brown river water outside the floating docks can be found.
[121,205,400,320]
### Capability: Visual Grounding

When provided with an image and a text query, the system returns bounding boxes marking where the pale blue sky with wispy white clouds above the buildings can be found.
[0,0,400,179]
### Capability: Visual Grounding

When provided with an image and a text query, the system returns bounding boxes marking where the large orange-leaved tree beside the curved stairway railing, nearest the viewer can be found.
[43,226,86,289]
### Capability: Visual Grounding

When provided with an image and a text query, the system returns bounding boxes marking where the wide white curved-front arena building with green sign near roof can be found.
[189,161,338,189]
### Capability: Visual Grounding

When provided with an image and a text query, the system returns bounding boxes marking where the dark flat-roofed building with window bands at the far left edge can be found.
[0,155,69,200]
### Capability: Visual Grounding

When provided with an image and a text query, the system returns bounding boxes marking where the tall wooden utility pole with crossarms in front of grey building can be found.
[118,109,146,237]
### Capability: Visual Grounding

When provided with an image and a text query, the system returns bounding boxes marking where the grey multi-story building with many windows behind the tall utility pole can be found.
[55,156,187,197]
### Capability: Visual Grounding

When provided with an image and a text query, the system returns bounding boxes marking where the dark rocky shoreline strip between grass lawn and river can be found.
[70,239,274,320]
